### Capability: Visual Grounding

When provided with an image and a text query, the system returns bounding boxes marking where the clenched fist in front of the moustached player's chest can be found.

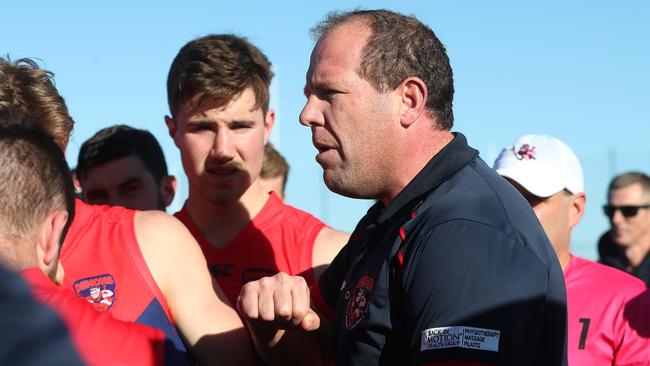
[237,272,320,331]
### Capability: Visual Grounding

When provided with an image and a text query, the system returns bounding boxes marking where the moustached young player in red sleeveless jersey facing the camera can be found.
[165,34,348,303]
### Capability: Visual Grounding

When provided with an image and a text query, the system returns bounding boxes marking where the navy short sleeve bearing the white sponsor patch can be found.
[401,220,566,365]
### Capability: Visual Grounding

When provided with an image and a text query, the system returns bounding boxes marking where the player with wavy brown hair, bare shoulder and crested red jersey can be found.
[0,59,254,364]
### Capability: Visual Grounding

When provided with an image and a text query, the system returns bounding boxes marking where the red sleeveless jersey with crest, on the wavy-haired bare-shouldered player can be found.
[61,200,187,352]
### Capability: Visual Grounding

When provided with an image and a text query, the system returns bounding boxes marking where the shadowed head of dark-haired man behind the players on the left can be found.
[75,125,176,211]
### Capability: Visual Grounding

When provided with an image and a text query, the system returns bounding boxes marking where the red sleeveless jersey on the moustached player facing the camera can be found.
[174,193,325,305]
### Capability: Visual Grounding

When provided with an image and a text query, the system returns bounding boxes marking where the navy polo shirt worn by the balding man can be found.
[314,133,566,366]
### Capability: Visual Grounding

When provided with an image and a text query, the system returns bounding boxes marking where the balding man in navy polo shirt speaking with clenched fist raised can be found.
[239,11,566,365]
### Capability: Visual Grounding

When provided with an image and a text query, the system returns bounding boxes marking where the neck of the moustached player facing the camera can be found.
[185,179,269,248]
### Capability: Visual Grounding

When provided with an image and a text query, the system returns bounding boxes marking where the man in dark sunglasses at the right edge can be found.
[598,172,650,285]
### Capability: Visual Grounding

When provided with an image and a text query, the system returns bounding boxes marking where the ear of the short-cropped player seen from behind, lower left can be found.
[37,210,68,274]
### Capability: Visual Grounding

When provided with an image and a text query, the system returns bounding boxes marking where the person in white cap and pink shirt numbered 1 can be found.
[494,135,650,365]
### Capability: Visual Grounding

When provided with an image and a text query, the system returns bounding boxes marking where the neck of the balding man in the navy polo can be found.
[379,128,454,207]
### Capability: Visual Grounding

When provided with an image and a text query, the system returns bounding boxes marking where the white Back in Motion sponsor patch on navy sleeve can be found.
[420,326,501,352]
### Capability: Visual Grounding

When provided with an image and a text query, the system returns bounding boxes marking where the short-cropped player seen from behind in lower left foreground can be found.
[0,121,184,365]
